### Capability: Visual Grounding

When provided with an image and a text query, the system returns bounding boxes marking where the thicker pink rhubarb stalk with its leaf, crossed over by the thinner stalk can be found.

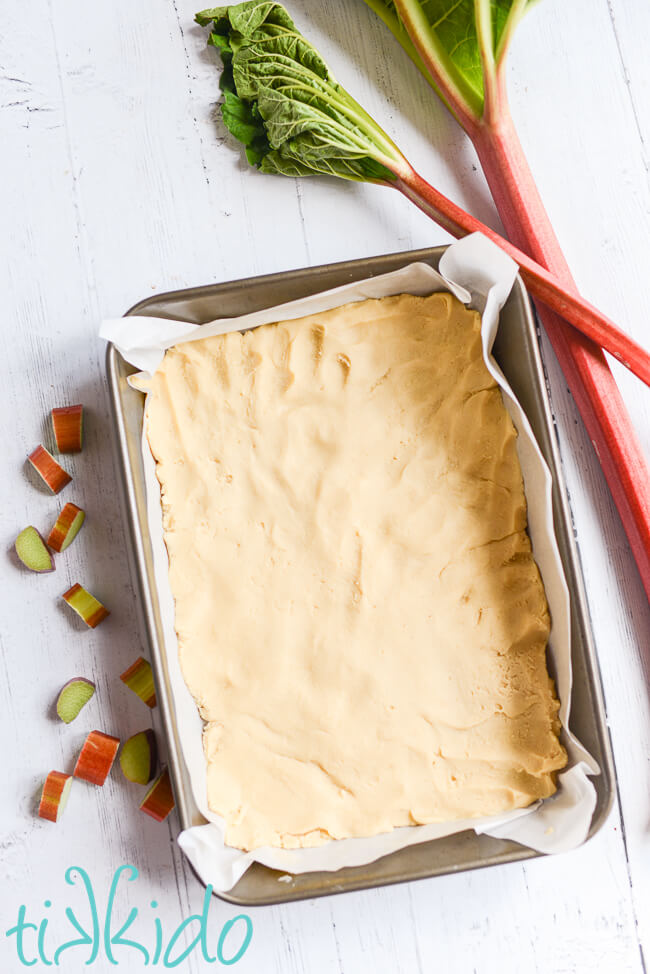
[365,0,650,597]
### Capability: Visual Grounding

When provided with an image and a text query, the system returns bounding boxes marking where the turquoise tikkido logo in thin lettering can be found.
[5,865,253,969]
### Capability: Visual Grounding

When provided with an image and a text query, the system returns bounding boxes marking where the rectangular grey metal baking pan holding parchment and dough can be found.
[107,247,614,907]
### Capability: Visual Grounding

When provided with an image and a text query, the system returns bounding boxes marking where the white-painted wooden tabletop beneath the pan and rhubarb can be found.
[0,0,650,974]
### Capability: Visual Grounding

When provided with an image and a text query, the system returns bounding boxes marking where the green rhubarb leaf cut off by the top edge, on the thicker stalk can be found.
[365,0,537,119]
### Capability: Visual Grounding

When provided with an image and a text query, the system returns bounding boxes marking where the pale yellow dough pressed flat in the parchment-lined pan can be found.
[147,293,566,849]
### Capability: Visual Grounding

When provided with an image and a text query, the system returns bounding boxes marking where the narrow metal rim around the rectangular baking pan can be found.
[106,247,615,908]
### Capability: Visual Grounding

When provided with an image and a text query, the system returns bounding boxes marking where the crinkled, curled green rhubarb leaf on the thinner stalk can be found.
[196,0,405,182]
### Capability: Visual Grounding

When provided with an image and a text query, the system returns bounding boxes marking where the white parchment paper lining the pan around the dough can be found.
[100,234,599,891]
